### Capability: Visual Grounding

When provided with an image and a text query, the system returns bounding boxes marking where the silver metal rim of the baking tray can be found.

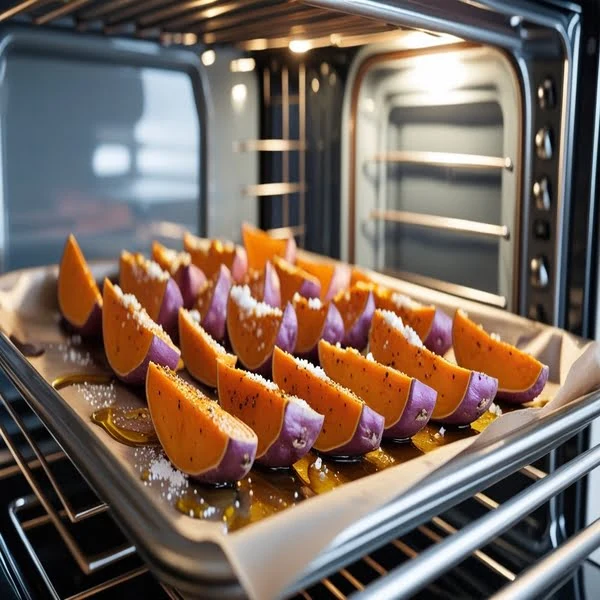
[0,261,600,597]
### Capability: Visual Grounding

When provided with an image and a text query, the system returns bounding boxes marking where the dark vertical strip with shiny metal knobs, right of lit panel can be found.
[521,61,565,324]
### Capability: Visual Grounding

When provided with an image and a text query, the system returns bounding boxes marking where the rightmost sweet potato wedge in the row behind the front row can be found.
[358,282,452,355]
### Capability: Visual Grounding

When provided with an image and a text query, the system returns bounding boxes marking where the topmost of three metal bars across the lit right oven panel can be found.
[370,151,514,171]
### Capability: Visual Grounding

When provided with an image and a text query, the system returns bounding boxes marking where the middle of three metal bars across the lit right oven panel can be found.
[369,209,510,240]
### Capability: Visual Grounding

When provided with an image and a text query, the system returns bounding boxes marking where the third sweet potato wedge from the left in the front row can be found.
[273,348,384,456]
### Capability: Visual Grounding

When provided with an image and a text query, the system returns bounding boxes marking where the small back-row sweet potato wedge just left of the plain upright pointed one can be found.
[183,233,248,282]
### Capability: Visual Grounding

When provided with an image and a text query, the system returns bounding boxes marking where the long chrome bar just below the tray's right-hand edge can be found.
[354,445,600,600]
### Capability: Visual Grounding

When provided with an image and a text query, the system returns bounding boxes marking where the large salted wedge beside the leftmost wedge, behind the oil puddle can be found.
[102,279,180,384]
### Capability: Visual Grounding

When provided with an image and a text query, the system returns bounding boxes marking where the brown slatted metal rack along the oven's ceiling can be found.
[0,0,406,51]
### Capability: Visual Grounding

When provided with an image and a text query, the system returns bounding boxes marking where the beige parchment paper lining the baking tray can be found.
[0,264,600,600]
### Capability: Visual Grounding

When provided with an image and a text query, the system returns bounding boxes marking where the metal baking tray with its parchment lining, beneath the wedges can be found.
[0,263,600,598]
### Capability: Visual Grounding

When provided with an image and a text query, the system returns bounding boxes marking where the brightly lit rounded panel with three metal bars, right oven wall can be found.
[348,48,521,309]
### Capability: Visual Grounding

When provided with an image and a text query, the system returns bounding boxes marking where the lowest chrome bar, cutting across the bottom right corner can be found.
[490,519,600,600]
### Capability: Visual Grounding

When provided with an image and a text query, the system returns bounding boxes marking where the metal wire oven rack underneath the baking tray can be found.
[0,376,600,600]
